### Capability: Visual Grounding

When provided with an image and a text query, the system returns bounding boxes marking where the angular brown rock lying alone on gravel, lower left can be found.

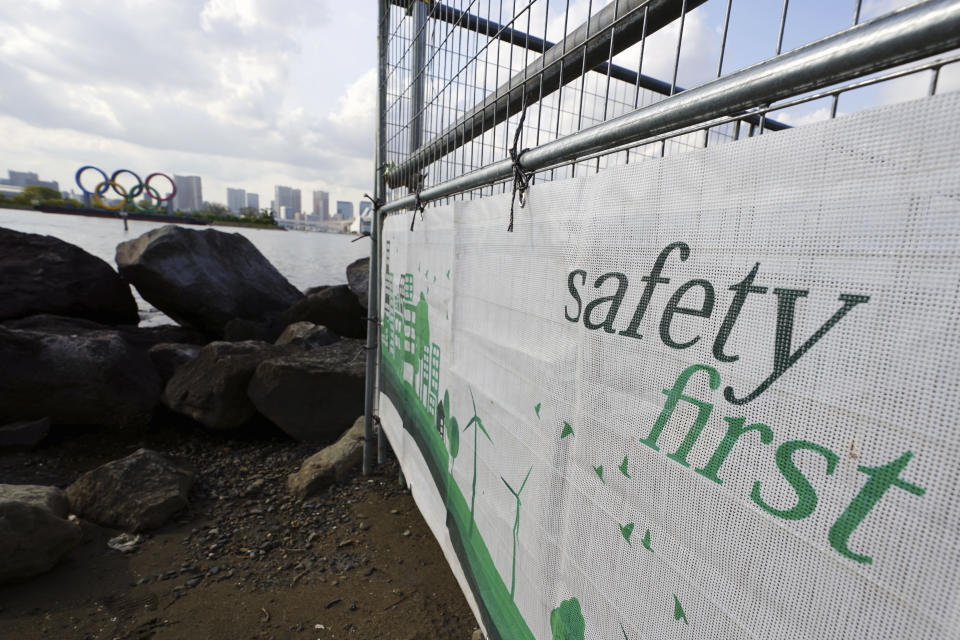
[67,449,194,532]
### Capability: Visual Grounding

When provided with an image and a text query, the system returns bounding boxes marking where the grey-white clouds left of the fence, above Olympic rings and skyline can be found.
[0,0,376,204]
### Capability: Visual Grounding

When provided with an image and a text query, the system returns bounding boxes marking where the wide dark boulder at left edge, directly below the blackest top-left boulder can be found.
[0,327,161,426]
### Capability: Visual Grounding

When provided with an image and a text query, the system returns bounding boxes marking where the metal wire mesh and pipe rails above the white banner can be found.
[377,0,960,210]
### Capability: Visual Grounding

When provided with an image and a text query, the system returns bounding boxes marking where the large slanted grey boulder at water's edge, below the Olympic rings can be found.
[116,225,303,338]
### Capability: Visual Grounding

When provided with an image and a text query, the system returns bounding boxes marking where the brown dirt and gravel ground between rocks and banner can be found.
[0,416,476,640]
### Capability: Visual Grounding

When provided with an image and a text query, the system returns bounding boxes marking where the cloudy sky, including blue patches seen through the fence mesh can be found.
[0,0,960,208]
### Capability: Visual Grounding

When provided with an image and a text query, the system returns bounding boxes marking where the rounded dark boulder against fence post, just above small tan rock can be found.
[248,338,366,444]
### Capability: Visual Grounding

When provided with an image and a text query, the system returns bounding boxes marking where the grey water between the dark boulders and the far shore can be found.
[0,209,370,326]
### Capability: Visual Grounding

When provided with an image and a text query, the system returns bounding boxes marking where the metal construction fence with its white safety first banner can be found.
[365,0,960,640]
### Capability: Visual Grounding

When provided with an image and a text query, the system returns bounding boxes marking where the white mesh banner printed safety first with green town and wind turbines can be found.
[380,93,960,640]
